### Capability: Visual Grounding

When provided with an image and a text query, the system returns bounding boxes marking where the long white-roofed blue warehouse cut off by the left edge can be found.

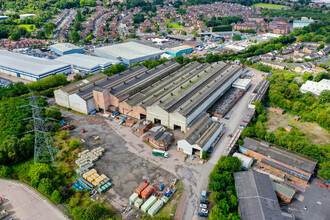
[0,50,72,81]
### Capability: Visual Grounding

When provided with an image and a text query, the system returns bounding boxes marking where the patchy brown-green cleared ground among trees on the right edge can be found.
[267,112,330,145]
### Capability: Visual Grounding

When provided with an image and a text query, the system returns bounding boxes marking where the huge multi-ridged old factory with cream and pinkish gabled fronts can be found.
[55,61,242,132]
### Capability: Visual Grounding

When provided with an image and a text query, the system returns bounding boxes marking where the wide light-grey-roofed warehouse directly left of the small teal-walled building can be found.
[94,42,164,65]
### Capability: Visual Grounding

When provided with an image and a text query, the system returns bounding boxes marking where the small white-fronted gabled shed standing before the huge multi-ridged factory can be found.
[177,116,224,158]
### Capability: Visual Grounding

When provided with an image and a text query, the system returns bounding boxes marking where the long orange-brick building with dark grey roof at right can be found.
[239,137,317,185]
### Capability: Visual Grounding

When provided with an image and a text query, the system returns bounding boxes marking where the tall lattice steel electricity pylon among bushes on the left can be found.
[21,95,58,165]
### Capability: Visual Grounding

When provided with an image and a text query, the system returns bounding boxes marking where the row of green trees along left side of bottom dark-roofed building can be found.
[209,156,242,220]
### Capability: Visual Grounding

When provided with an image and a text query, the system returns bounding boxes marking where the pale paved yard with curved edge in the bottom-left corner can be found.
[0,180,67,220]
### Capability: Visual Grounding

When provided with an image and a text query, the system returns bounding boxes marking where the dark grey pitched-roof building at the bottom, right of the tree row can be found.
[234,171,295,220]
